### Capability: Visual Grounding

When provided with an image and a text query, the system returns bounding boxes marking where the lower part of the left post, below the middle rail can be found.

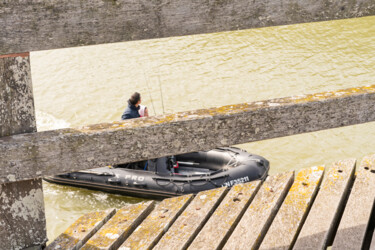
[0,179,47,249]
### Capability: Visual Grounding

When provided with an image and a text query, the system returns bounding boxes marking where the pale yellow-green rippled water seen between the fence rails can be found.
[31,17,375,242]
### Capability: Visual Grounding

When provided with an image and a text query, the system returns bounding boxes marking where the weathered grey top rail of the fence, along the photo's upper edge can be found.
[0,0,375,54]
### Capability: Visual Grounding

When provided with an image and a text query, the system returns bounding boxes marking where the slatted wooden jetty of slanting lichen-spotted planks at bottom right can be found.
[47,155,375,250]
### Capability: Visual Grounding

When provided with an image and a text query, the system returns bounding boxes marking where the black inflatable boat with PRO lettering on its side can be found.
[45,147,269,199]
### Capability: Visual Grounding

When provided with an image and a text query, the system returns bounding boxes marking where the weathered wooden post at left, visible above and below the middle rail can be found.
[0,55,47,249]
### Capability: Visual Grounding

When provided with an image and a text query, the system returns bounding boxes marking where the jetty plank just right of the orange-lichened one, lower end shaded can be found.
[293,159,356,249]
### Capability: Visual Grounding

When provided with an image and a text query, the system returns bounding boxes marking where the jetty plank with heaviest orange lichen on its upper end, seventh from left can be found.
[260,166,324,250]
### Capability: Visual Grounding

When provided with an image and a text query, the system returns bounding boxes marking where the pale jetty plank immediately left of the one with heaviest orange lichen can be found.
[223,172,294,249]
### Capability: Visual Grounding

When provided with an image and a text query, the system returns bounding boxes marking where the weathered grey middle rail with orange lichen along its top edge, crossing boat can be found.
[0,85,375,183]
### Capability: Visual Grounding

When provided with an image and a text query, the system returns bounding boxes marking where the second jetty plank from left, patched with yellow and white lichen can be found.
[80,201,154,250]
